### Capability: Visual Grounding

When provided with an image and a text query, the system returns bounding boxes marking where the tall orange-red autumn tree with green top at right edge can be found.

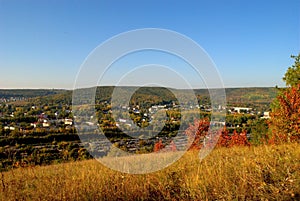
[270,54,300,143]
